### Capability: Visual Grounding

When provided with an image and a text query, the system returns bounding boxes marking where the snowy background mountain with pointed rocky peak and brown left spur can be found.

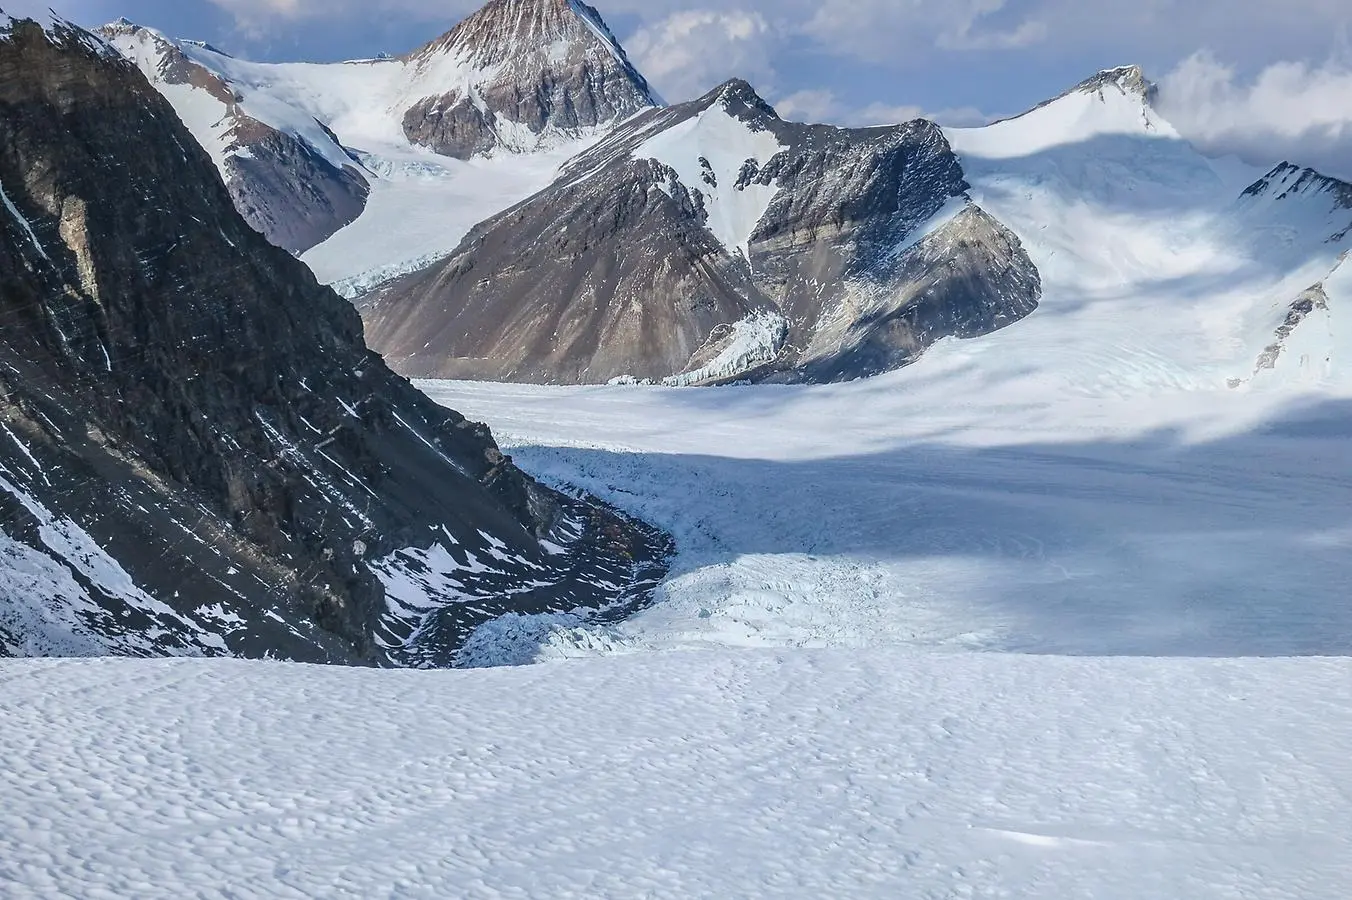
[100,0,657,259]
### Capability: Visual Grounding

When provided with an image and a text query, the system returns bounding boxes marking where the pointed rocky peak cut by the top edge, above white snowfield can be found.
[403,0,657,159]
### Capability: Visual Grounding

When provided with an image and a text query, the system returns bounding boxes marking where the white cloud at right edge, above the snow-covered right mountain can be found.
[1159,53,1352,178]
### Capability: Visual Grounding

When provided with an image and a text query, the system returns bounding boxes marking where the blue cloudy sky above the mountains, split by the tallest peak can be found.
[0,0,1352,178]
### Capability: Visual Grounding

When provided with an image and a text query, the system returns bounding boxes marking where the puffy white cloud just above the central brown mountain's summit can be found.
[625,9,775,101]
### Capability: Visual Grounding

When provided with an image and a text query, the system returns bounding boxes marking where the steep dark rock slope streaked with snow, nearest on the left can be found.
[0,16,664,665]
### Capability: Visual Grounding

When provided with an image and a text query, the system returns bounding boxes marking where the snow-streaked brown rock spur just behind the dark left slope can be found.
[99,19,370,254]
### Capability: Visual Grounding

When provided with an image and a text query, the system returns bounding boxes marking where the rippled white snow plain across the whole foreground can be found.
[0,650,1352,899]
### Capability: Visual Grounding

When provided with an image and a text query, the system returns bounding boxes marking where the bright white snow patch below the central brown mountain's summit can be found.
[633,103,784,259]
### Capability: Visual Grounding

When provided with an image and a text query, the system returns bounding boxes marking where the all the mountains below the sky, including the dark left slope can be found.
[0,0,1352,665]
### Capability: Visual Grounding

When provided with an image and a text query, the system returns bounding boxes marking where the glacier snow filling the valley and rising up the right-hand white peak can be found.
[420,85,1352,659]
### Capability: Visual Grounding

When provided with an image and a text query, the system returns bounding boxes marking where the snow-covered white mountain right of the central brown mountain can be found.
[945,59,1352,391]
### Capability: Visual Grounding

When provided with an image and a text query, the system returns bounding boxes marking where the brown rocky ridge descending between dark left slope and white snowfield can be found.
[99,19,370,254]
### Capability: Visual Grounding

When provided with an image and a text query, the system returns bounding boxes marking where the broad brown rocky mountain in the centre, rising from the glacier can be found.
[361,81,1041,384]
